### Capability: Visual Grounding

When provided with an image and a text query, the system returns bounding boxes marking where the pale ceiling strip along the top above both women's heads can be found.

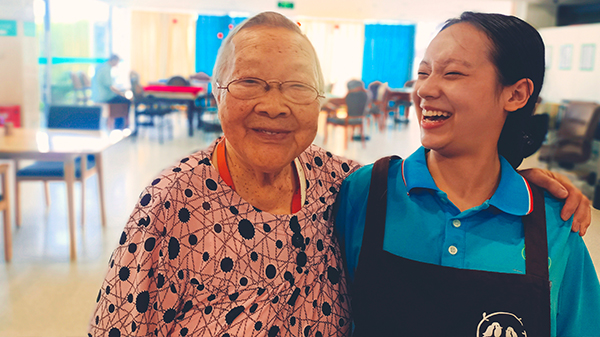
[102,0,600,22]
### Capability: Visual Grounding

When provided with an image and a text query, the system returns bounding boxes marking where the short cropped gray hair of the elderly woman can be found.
[211,12,325,95]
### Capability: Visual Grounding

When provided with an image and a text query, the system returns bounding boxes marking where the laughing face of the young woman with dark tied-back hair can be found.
[413,23,509,155]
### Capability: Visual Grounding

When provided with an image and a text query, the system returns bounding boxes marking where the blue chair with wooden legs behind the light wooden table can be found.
[15,105,105,226]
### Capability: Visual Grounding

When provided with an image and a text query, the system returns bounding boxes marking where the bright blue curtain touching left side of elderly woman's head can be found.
[196,15,246,76]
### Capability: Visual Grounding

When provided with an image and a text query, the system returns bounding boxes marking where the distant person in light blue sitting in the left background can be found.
[92,54,131,110]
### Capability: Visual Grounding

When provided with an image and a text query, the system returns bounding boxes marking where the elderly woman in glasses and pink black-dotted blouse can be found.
[89,13,589,337]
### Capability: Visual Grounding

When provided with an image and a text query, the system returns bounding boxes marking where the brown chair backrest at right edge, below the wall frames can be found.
[557,101,600,142]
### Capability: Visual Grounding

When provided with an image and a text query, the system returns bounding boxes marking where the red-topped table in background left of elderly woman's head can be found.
[144,85,204,137]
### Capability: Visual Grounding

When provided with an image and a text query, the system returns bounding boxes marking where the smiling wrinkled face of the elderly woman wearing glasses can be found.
[217,27,320,172]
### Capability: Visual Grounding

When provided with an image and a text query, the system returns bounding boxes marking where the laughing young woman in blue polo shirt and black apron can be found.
[336,12,600,337]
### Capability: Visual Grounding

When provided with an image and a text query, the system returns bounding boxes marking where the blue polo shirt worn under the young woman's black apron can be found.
[336,147,600,336]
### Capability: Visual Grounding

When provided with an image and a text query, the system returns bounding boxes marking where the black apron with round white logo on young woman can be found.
[351,157,550,337]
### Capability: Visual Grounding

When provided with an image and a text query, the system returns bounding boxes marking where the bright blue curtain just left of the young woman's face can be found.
[362,24,415,88]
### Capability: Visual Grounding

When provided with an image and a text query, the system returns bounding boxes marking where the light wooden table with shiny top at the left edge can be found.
[0,128,124,260]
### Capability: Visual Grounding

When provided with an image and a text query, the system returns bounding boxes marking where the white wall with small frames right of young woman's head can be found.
[539,24,600,103]
